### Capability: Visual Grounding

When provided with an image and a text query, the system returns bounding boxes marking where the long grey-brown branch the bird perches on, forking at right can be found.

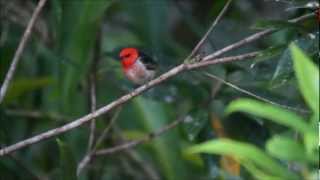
[0,14,314,156]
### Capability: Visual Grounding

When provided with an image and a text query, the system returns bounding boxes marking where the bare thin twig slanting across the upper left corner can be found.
[0,0,47,104]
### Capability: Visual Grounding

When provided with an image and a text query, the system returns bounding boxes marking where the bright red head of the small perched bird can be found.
[119,48,139,69]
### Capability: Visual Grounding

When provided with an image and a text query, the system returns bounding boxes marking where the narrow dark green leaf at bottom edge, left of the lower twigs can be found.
[56,139,77,180]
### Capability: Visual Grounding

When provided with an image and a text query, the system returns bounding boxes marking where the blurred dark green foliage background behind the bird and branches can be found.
[0,0,319,180]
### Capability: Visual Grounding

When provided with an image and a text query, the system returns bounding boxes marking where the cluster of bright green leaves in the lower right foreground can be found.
[188,44,319,179]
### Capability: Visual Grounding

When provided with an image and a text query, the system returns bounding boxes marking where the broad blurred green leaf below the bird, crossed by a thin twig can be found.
[134,96,187,180]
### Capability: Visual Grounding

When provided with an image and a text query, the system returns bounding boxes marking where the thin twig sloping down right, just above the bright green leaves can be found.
[203,72,309,113]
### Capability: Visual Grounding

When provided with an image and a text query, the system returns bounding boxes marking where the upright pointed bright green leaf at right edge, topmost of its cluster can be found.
[290,44,319,113]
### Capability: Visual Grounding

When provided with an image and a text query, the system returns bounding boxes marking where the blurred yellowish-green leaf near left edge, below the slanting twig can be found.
[4,77,52,103]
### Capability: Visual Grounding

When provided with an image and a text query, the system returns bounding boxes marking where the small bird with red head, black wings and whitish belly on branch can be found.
[119,47,157,85]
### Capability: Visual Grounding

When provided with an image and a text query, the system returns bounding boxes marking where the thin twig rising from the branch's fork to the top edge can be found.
[187,0,232,59]
